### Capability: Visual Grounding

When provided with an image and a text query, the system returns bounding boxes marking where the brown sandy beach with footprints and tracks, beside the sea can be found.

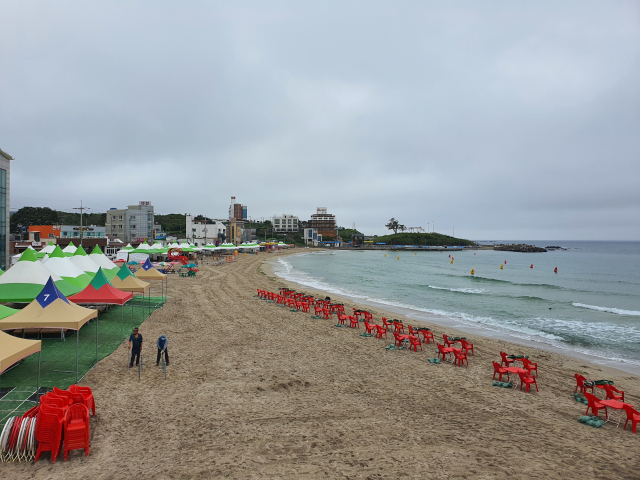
[0,252,640,480]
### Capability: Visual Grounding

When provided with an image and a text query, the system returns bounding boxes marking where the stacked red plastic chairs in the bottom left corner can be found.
[34,385,96,463]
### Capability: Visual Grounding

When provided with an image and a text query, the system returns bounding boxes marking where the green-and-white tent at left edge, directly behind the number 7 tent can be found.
[0,250,82,303]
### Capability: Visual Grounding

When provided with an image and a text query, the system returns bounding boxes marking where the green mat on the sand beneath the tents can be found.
[0,296,165,431]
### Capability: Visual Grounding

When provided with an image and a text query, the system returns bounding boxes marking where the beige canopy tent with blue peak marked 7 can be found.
[0,277,98,382]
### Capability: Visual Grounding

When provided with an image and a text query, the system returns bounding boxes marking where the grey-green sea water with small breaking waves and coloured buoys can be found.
[274,241,640,370]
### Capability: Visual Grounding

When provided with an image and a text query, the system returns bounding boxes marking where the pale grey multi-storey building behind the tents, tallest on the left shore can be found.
[105,201,155,242]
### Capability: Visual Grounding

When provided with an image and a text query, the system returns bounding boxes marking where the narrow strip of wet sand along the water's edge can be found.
[261,249,640,377]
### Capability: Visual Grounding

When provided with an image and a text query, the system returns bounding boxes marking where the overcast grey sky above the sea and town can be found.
[0,0,640,240]
